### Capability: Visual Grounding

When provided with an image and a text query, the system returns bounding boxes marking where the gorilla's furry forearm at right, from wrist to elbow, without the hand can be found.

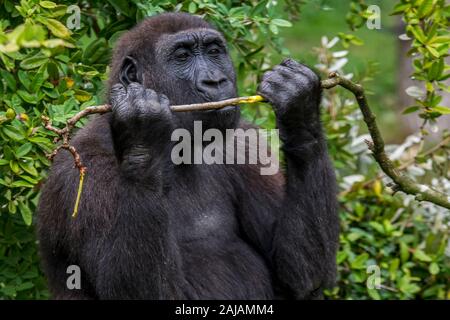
[274,123,339,298]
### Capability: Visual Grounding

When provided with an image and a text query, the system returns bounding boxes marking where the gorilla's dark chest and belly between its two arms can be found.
[164,166,272,299]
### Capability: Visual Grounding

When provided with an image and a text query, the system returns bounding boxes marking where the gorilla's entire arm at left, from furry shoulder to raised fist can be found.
[39,85,183,299]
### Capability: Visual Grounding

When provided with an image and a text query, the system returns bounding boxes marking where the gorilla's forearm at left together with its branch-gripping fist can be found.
[98,83,184,299]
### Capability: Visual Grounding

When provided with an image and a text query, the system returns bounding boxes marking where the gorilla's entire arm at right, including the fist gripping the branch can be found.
[236,59,339,298]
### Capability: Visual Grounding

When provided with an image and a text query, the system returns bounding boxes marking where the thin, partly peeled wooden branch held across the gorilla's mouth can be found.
[42,72,450,210]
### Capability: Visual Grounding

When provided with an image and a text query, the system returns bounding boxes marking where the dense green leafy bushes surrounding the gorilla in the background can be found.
[0,0,450,299]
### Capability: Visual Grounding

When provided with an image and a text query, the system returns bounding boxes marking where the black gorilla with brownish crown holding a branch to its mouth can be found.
[38,13,339,299]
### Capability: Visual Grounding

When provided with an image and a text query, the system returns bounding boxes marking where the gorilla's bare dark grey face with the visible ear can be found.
[121,28,239,129]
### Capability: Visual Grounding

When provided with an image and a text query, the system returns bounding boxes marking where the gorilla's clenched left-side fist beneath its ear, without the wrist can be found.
[110,82,173,148]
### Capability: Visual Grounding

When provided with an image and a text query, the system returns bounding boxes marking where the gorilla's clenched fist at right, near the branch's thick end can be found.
[258,59,321,129]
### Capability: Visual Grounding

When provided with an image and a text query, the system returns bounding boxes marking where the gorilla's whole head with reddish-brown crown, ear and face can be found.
[109,13,239,129]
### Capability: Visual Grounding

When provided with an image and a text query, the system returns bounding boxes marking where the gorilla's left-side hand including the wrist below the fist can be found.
[110,83,173,179]
